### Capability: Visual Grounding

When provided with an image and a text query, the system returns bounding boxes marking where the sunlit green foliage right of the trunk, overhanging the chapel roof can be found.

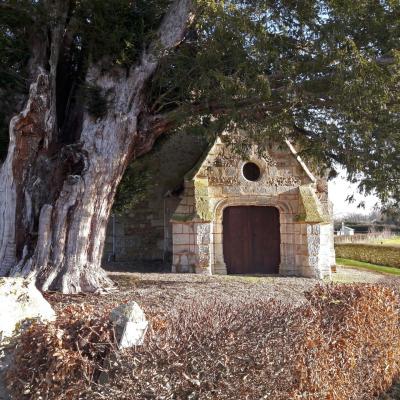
[151,0,400,202]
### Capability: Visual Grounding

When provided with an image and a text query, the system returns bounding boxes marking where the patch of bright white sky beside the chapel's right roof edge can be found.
[328,170,378,218]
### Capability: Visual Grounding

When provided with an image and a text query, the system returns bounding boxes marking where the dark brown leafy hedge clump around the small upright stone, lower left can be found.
[7,305,116,400]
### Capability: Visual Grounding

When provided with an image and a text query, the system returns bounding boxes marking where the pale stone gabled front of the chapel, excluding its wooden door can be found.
[171,140,334,277]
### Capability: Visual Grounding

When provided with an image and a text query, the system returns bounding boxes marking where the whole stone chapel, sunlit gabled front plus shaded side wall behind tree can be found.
[104,133,335,278]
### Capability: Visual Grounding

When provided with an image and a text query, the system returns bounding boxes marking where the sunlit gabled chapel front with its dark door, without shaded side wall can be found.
[171,139,335,279]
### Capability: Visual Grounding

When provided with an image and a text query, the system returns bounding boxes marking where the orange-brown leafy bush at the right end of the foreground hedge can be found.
[303,285,400,400]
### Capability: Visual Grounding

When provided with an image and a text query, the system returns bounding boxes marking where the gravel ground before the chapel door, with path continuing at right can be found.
[46,267,400,315]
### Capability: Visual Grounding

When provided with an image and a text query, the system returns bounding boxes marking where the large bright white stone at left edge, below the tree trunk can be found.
[0,278,56,341]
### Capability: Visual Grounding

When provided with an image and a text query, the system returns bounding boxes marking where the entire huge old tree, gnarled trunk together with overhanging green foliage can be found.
[0,0,400,292]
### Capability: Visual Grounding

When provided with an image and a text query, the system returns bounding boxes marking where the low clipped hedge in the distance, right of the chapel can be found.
[335,243,400,268]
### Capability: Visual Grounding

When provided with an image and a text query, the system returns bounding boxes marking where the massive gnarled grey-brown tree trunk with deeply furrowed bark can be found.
[0,0,191,293]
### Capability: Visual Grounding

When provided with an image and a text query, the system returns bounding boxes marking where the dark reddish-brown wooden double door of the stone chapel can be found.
[223,206,280,274]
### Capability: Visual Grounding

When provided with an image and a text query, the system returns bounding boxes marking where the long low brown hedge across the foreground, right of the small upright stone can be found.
[6,285,400,400]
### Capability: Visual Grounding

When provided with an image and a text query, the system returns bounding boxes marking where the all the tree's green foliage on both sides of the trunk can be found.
[0,0,400,203]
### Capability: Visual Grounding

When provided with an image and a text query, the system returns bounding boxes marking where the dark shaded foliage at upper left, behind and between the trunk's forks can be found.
[0,0,170,161]
